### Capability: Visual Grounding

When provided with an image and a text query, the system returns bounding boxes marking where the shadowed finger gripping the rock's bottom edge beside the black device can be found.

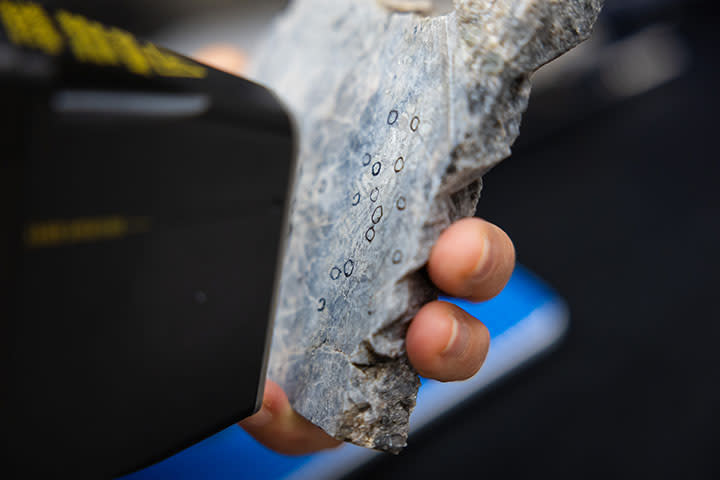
[239,380,341,455]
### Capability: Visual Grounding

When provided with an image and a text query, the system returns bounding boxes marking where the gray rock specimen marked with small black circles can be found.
[255,0,602,452]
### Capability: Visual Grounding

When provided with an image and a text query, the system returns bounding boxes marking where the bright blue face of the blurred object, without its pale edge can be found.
[125,267,556,480]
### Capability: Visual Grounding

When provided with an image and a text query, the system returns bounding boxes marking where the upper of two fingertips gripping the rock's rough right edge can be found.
[428,218,515,302]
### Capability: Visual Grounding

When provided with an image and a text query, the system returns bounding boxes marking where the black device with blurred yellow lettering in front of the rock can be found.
[0,0,294,478]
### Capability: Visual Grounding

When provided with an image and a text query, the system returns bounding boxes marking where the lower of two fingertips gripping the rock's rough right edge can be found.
[407,302,490,382]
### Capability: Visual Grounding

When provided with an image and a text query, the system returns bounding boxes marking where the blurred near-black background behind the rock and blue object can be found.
[38,0,720,479]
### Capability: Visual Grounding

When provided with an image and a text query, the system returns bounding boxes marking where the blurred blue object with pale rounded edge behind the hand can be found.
[124,267,568,480]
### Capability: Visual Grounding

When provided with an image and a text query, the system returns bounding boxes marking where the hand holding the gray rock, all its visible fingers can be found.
[191,46,515,455]
